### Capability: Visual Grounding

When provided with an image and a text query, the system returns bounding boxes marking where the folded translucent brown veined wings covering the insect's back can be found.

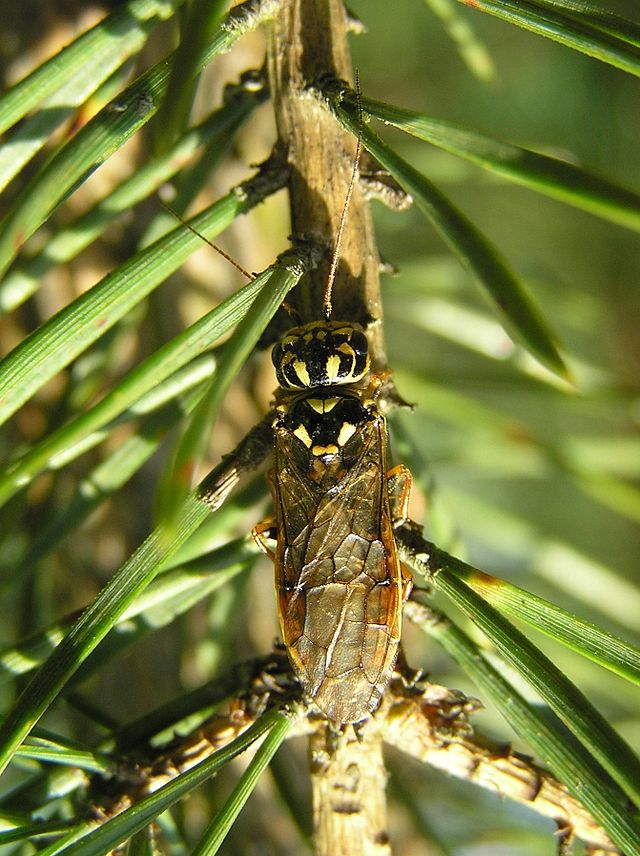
[274,416,402,723]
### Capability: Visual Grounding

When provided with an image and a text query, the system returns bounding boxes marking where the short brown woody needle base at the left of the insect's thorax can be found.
[198,412,274,511]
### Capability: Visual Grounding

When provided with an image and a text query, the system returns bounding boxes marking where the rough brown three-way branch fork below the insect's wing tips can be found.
[92,652,621,856]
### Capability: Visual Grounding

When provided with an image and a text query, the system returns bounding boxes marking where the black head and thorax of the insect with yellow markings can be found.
[272,321,372,457]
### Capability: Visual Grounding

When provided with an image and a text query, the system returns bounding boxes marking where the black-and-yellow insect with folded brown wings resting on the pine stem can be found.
[254,115,411,724]
